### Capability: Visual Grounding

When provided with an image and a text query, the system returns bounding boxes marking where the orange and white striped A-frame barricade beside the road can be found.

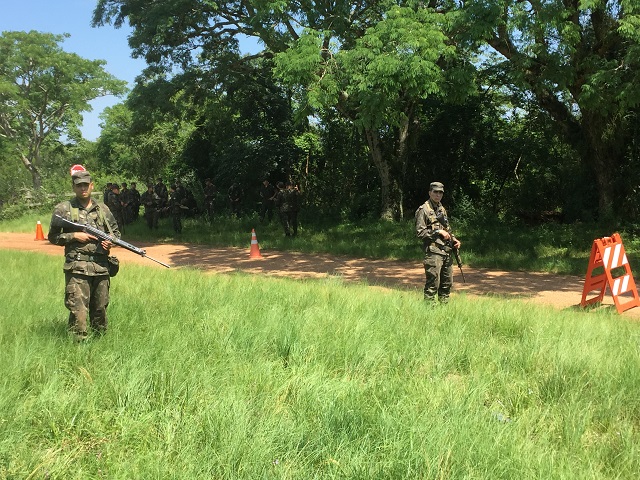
[580,233,640,313]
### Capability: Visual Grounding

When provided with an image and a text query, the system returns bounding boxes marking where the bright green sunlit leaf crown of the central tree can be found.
[276,6,455,128]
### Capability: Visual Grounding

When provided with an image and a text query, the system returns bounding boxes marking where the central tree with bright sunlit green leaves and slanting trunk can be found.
[276,6,473,218]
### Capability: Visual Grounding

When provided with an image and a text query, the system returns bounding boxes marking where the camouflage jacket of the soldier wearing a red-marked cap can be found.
[48,198,120,276]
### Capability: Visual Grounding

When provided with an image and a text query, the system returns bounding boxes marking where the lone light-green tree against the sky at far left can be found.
[0,31,126,189]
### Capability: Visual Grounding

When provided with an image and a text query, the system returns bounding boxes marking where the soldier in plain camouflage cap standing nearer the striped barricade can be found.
[416,182,460,303]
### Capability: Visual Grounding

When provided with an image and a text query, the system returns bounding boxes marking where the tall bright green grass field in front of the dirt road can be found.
[0,250,640,479]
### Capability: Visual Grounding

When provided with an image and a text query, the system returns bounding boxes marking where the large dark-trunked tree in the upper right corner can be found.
[458,0,640,218]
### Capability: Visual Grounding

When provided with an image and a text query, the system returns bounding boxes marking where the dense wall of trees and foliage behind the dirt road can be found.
[94,0,640,221]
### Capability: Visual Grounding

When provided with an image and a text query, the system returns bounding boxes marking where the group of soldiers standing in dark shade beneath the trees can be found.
[103,178,300,236]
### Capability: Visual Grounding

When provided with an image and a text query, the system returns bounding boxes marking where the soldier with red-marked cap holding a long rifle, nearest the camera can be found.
[49,171,120,341]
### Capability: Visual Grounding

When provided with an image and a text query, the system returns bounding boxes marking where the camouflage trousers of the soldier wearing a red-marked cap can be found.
[64,272,111,340]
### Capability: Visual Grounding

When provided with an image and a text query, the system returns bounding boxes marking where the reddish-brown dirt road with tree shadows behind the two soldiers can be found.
[0,232,640,317]
